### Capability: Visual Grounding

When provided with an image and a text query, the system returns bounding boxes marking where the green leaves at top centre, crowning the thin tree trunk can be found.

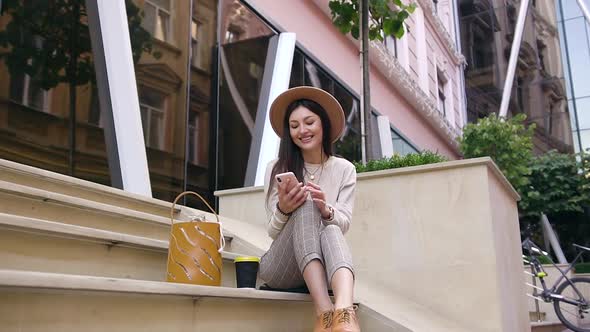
[329,0,416,41]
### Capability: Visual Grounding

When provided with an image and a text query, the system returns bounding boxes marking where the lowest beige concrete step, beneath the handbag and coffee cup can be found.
[0,270,400,332]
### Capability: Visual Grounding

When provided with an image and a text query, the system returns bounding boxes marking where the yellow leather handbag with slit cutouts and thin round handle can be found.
[166,191,225,286]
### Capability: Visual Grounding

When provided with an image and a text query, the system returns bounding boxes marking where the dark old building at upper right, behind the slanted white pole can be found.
[459,0,575,153]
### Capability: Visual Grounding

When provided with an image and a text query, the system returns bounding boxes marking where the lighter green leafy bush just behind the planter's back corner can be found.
[459,113,535,192]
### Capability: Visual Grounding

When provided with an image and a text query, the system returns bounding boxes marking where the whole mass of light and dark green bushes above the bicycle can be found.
[459,114,590,254]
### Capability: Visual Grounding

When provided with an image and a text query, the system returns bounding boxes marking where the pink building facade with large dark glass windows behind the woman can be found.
[0,0,467,208]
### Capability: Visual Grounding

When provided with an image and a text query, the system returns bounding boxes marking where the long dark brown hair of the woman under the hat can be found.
[266,99,333,200]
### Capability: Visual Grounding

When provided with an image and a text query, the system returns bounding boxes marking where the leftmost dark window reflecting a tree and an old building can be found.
[0,0,110,184]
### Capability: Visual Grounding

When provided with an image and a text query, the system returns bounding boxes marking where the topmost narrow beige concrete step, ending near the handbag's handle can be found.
[0,159,179,218]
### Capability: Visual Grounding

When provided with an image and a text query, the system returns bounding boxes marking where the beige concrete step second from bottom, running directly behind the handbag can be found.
[0,213,245,287]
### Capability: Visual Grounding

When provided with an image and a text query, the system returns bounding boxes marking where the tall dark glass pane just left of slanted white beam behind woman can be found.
[217,0,275,189]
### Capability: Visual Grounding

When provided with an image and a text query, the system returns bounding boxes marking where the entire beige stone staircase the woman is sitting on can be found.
[0,160,402,332]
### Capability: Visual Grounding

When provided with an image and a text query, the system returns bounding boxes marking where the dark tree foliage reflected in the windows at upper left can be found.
[0,0,152,90]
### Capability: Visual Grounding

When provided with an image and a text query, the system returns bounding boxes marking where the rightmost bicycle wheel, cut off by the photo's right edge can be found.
[553,277,590,332]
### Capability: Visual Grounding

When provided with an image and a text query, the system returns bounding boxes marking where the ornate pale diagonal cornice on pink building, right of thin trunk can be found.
[369,41,461,153]
